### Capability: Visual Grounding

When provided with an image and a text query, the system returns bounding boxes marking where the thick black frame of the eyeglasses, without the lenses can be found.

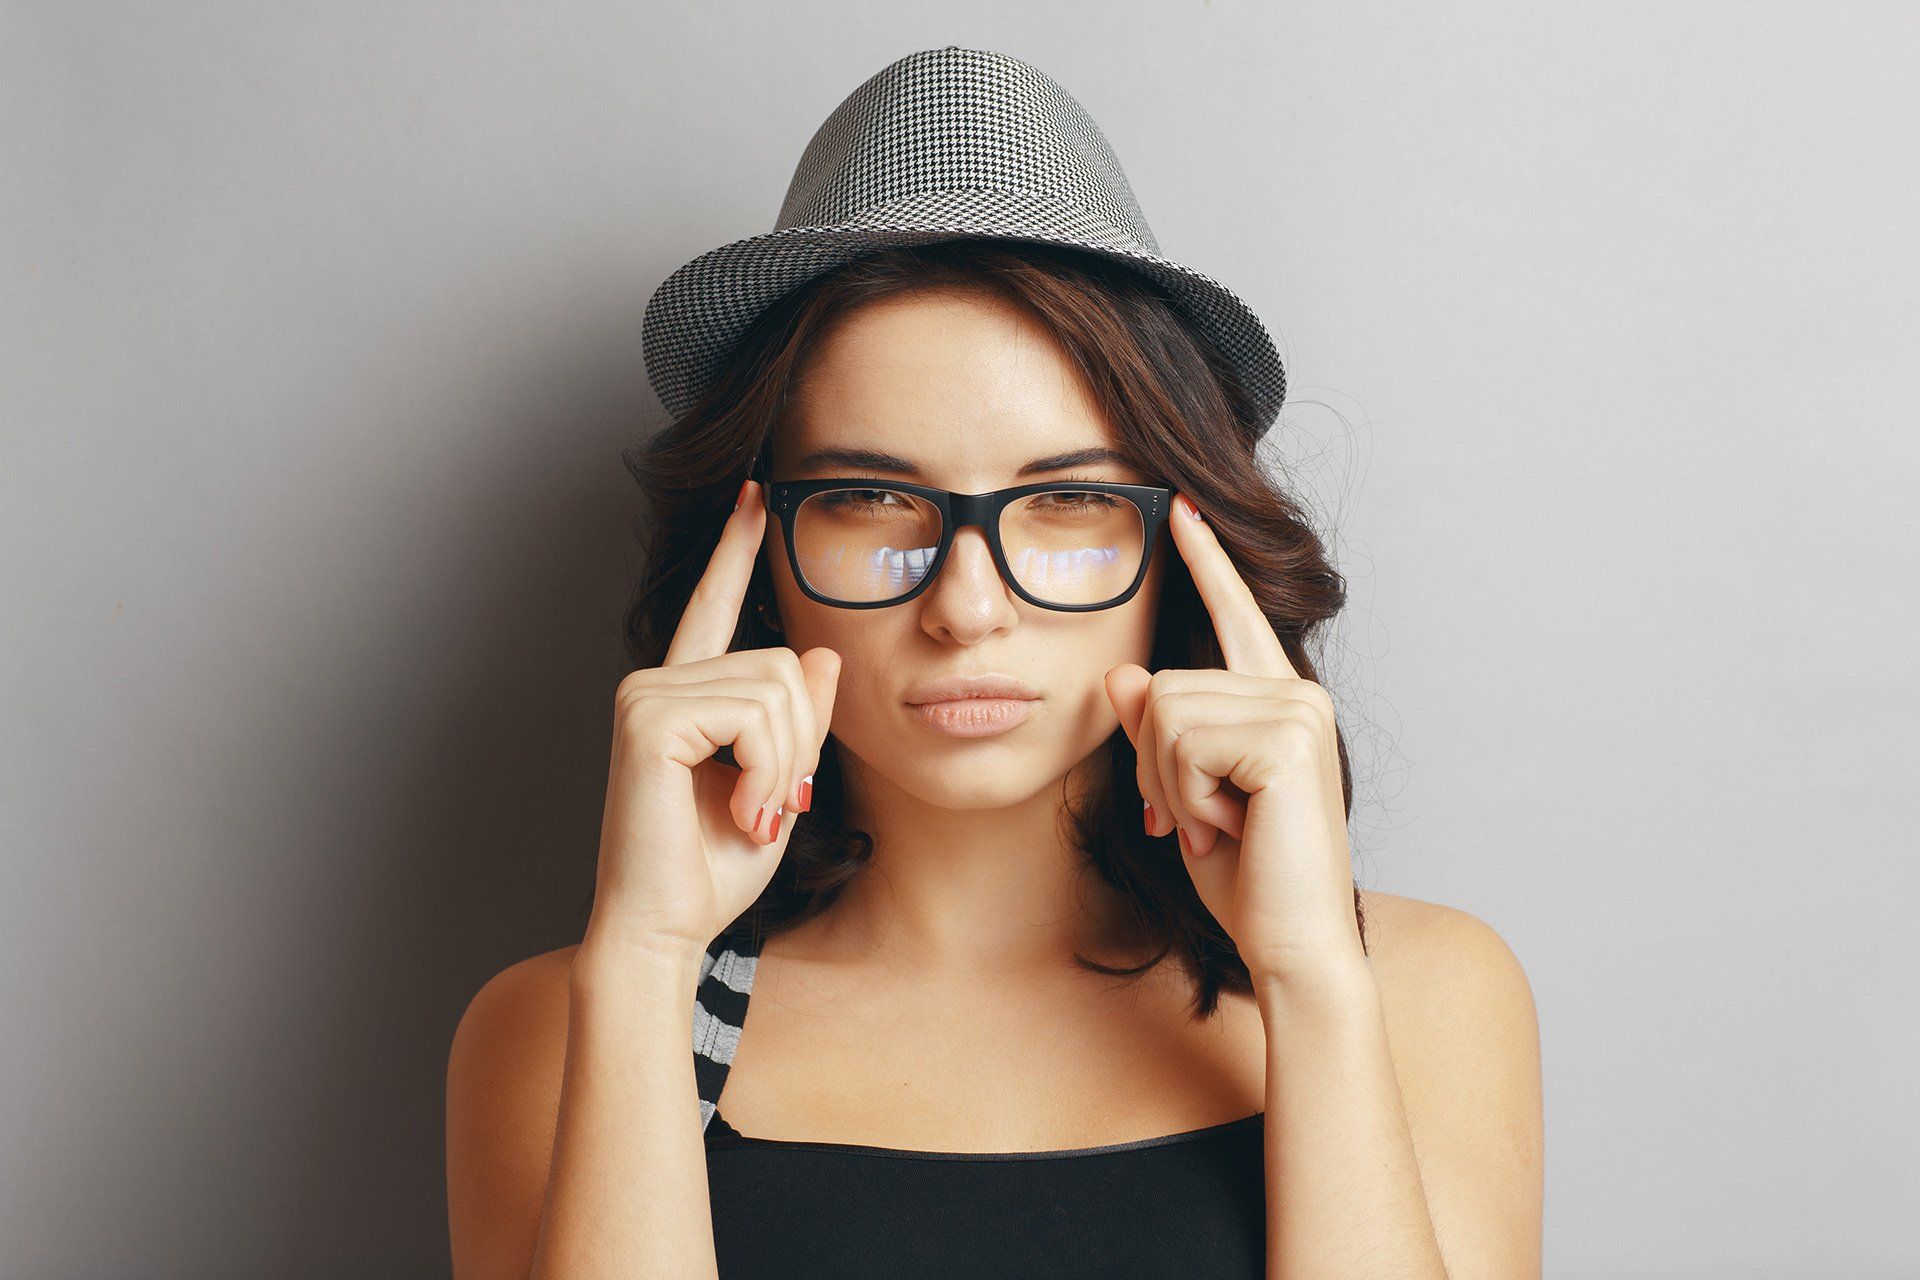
[747,451,1173,614]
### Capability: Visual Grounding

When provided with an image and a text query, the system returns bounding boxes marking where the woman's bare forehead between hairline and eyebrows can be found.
[776,290,1116,478]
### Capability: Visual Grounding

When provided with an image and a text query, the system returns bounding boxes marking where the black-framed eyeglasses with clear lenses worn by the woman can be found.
[747,453,1173,612]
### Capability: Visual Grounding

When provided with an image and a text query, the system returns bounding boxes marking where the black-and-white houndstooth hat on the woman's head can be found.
[641,44,1286,430]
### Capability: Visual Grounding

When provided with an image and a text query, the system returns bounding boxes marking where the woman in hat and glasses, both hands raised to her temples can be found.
[447,48,1542,1280]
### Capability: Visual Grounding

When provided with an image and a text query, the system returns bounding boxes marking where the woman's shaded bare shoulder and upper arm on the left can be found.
[445,946,580,1280]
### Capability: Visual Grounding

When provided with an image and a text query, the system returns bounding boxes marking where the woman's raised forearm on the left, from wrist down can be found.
[532,938,718,1280]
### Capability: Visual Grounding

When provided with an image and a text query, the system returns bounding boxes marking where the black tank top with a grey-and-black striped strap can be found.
[693,935,1267,1280]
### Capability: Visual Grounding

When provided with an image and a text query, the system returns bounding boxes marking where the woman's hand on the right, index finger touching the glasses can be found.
[1106,495,1365,979]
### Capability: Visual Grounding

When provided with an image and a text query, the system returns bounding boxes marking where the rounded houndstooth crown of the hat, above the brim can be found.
[774,44,1160,253]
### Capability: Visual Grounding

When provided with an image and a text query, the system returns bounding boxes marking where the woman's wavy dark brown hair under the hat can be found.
[606,240,1367,1019]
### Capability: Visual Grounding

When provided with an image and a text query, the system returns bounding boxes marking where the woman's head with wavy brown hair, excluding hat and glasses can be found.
[606,240,1357,1015]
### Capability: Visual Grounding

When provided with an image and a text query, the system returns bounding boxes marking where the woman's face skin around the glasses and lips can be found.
[766,290,1165,808]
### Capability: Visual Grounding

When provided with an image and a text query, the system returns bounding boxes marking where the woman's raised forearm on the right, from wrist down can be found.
[1256,958,1446,1280]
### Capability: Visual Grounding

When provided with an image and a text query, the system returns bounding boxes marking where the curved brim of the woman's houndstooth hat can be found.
[641,192,1286,434]
